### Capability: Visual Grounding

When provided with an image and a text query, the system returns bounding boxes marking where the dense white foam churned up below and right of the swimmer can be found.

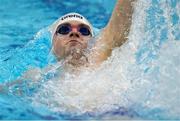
[31,0,180,116]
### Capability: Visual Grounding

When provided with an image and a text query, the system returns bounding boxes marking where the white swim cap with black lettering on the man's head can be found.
[50,13,94,39]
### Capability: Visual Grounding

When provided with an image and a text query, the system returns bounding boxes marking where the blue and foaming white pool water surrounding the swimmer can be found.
[0,0,180,119]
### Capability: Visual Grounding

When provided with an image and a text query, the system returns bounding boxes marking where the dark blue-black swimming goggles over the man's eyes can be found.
[56,23,92,36]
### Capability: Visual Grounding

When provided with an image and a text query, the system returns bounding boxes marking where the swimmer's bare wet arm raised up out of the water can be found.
[90,0,136,64]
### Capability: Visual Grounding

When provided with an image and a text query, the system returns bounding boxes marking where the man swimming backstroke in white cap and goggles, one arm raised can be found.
[50,0,135,68]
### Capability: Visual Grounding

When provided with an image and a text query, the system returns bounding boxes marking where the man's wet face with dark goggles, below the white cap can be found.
[53,21,92,59]
